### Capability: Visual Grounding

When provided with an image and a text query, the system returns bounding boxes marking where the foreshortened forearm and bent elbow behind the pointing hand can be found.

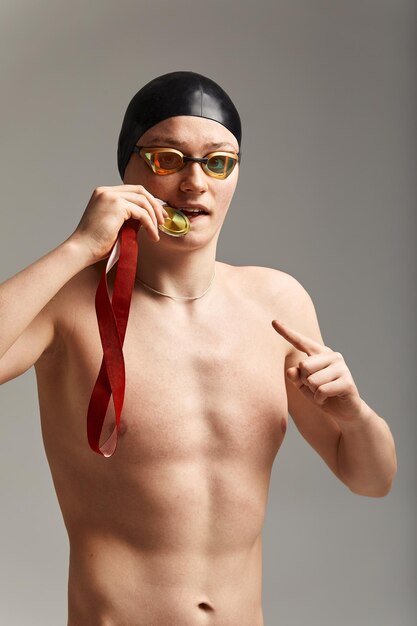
[338,402,397,497]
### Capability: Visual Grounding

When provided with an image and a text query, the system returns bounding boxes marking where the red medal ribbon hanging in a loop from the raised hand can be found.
[87,219,139,457]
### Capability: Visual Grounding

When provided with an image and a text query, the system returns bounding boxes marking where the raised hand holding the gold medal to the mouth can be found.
[69,185,168,265]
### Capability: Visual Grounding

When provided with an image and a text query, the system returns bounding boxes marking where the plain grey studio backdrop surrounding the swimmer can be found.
[0,0,417,626]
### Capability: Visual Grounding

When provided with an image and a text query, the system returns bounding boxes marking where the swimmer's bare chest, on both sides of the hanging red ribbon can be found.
[41,286,287,465]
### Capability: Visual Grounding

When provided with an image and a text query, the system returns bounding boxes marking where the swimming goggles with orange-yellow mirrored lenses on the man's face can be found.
[133,146,240,180]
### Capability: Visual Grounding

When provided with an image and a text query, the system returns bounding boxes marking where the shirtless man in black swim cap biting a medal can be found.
[0,73,396,626]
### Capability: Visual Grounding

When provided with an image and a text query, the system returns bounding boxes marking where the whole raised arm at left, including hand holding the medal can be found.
[0,185,166,384]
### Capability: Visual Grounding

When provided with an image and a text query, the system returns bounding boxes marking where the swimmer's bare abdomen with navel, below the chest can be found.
[67,454,267,626]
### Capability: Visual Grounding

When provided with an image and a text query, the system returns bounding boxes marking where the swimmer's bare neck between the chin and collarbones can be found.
[136,230,216,299]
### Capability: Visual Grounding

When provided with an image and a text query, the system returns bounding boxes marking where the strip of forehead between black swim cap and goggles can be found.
[137,115,239,152]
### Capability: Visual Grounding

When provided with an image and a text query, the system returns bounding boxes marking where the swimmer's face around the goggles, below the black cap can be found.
[123,116,239,240]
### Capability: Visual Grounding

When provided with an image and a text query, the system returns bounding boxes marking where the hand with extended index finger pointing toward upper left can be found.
[272,320,364,423]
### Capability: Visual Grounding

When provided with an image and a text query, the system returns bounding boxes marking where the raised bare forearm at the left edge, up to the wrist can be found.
[0,238,91,358]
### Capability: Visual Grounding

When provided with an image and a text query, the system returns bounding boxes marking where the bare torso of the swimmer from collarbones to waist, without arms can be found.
[36,264,288,626]
